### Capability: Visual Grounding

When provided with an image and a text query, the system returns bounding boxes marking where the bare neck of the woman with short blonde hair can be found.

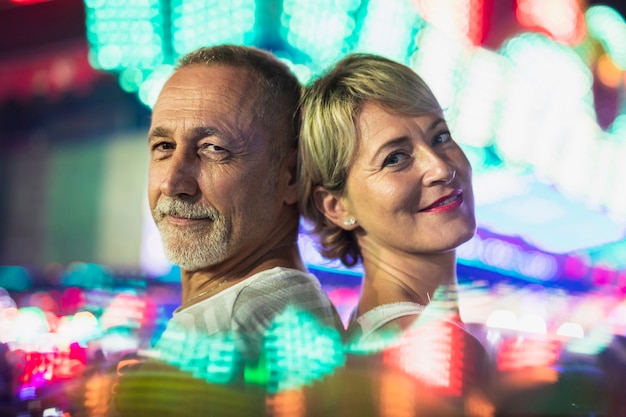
[358,240,457,315]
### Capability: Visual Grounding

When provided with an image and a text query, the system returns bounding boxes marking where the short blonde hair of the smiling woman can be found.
[298,54,441,266]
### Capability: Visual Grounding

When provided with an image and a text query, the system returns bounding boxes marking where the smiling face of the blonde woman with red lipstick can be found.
[343,102,476,254]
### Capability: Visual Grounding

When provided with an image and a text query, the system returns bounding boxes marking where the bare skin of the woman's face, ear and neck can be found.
[316,102,476,322]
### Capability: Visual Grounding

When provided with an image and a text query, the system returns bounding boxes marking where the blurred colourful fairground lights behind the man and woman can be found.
[0,0,626,415]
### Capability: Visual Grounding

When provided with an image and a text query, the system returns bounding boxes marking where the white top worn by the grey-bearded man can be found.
[151,267,341,382]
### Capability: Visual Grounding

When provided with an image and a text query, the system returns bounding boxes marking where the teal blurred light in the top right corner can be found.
[585,6,626,70]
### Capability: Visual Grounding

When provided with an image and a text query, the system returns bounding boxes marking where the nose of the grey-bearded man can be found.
[161,152,198,197]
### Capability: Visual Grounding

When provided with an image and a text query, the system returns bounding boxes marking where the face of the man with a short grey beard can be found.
[148,65,284,271]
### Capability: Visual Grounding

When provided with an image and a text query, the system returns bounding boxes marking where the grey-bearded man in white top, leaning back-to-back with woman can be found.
[148,45,339,360]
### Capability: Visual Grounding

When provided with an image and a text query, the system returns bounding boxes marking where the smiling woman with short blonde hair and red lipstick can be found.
[300,54,476,341]
